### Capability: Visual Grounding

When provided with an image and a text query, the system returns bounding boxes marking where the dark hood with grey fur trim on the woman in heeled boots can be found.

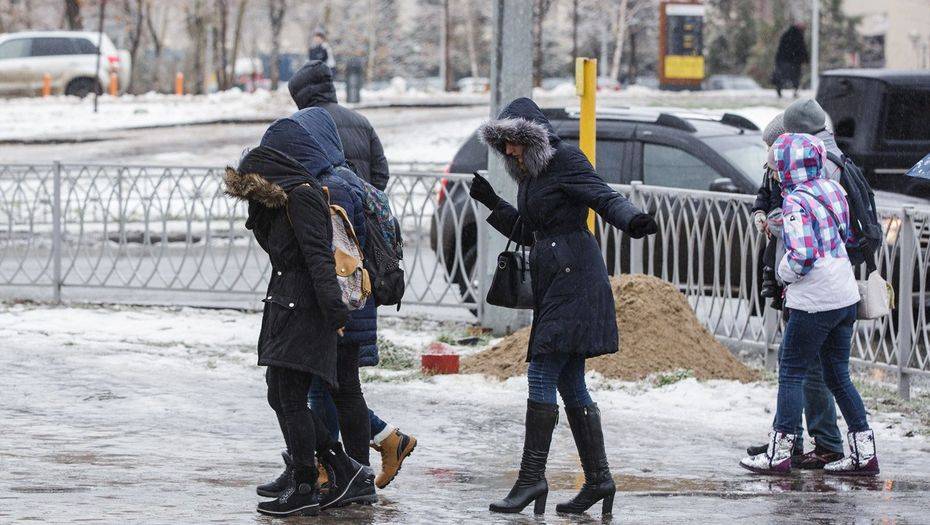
[479,97,559,181]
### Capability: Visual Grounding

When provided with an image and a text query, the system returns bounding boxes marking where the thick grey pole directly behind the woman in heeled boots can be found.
[478,0,533,333]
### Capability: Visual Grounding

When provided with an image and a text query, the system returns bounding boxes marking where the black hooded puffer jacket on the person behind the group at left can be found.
[287,60,390,191]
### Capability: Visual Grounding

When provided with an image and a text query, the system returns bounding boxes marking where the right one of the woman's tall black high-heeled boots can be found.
[555,403,617,516]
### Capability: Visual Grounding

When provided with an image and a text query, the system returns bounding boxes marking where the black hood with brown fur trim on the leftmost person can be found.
[225,146,319,208]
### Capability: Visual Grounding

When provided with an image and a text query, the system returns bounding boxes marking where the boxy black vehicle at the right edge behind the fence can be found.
[817,69,930,196]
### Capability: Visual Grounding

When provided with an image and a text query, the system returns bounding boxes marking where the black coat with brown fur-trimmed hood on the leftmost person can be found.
[226,146,349,385]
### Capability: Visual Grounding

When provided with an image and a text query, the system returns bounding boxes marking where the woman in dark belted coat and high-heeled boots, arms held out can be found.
[471,98,657,514]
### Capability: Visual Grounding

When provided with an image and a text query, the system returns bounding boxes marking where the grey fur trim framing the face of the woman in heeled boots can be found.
[479,118,555,181]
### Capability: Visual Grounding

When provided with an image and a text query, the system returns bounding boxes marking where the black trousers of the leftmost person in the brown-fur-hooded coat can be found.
[265,366,332,466]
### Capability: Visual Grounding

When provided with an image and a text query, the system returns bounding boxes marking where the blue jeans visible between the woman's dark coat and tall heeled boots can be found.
[526,354,594,408]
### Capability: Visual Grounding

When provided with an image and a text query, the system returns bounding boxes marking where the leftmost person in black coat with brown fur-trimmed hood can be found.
[225,145,373,516]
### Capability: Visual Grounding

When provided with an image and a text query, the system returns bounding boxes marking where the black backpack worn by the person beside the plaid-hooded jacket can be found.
[827,152,884,273]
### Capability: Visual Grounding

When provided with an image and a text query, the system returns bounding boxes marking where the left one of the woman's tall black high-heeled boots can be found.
[489,401,559,514]
